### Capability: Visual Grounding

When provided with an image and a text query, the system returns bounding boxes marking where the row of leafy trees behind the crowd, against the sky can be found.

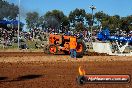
[0,0,132,32]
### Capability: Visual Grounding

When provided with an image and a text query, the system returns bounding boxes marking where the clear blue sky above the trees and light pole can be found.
[7,0,132,30]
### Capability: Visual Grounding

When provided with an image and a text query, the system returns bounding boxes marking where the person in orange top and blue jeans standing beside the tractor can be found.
[70,35,77,59]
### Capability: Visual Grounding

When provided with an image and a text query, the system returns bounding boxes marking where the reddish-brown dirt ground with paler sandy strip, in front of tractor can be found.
[0,54,132,88]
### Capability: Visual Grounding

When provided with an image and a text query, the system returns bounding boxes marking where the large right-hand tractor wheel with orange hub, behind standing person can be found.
[76,39,86,58]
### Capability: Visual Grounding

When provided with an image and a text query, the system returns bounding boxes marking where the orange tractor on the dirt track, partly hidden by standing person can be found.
[44,34,86,57]
